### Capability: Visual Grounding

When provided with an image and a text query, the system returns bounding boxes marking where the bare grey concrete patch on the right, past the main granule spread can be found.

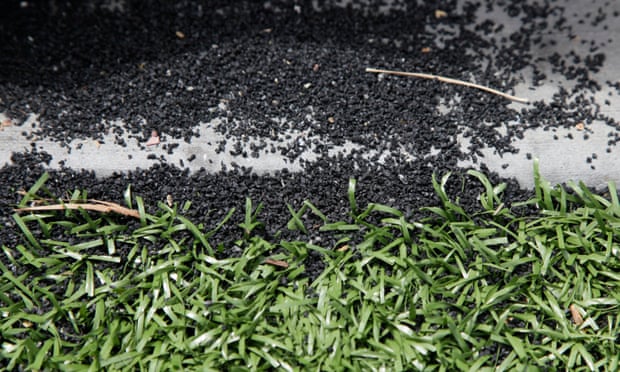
[470,1,620,188]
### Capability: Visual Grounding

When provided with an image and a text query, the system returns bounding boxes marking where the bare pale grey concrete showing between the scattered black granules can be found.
[0,0,620,187]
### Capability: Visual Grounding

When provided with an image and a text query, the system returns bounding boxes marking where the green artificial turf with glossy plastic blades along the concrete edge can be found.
[0,167,620,371]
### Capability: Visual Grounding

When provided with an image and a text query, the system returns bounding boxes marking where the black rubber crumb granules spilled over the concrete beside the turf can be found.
[0,0,620,282]
